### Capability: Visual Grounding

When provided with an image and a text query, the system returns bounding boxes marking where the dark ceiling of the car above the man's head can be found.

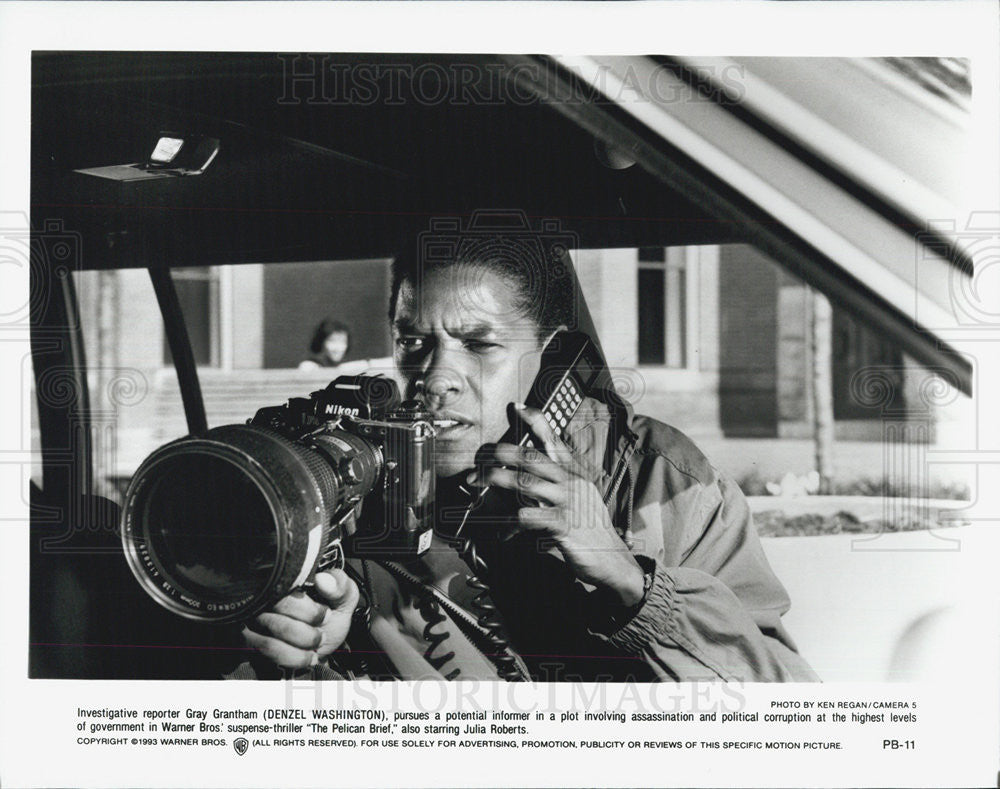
[32,52,741,268]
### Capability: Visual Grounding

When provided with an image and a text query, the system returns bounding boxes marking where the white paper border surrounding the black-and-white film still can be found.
[0,1,1000,786]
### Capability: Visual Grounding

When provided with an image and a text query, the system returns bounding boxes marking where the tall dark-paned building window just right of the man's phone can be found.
[638,247,687,368]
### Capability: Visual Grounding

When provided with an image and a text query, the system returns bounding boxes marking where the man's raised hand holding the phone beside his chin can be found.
[469,406,644,606]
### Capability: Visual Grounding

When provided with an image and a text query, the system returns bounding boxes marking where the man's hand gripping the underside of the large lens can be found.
[243,570,359,668]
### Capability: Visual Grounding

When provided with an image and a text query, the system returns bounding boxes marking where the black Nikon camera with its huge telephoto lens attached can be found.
[121,375,435,623]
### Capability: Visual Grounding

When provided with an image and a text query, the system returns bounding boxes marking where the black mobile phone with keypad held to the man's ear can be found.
[449,331,604,538]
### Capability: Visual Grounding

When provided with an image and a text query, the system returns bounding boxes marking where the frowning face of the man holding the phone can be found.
[392,266,541,477]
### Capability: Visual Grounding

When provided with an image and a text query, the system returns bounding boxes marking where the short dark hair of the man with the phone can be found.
[389,234,577,341]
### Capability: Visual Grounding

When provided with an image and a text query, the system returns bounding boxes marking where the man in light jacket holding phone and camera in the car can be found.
[236,232,815,681]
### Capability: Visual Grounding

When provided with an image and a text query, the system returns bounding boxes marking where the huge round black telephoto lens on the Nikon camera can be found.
[122,424,384,623]
